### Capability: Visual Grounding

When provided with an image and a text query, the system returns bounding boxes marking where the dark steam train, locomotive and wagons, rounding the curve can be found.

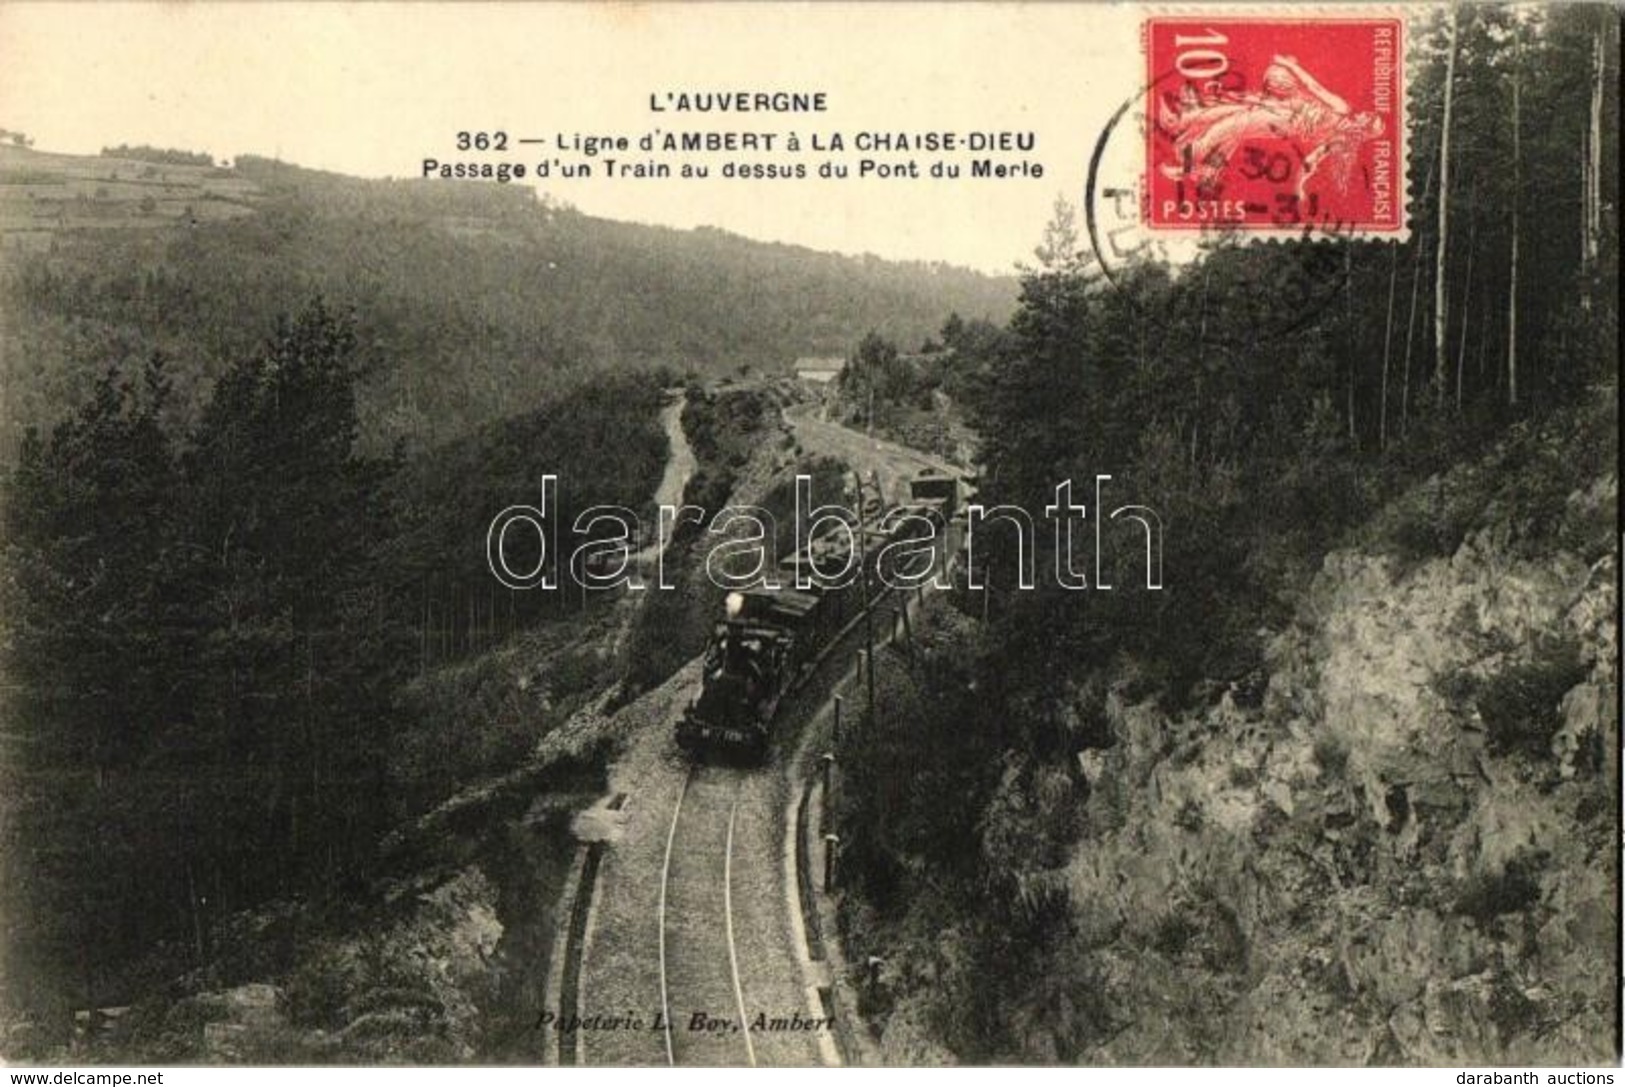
[676,476,957,762]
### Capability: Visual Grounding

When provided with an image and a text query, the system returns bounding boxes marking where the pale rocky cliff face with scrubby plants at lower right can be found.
[1053,454,1620,1064]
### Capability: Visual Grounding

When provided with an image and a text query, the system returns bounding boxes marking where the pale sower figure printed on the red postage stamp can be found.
[1159,55,1383,198]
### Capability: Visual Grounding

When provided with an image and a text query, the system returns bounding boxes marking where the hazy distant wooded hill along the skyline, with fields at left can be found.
[0,148,1016,457]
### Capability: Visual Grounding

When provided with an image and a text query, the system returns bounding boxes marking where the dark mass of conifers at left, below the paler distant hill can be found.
[0,299,666,1009]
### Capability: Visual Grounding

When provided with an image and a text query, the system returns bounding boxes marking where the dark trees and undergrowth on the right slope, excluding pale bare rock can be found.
[839,5,1620,1063]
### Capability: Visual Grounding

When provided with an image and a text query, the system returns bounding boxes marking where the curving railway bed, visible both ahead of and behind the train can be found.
[556,398,947,1068]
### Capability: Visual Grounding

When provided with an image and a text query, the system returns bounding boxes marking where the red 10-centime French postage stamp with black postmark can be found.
[1144,13,1407,237]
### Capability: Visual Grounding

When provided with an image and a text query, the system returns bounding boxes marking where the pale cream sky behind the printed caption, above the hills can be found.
[0,2,1141,271]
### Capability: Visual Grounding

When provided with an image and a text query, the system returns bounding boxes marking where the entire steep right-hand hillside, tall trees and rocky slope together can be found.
[837,5,1620,1064]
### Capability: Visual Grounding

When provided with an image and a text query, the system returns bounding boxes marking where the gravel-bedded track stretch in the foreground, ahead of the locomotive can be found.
[557,714,835,1068]
